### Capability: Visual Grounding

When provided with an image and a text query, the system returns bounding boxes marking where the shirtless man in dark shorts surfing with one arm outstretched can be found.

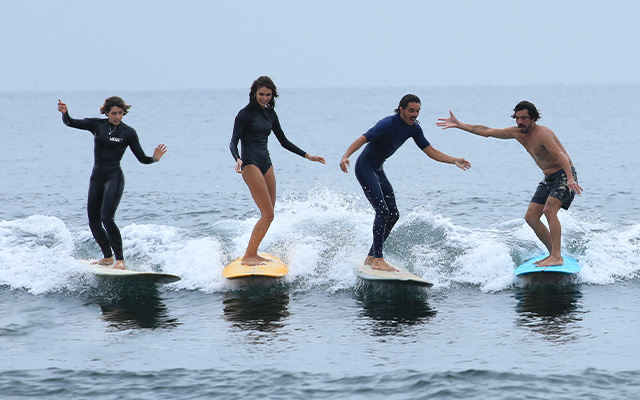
[436,101,582,267]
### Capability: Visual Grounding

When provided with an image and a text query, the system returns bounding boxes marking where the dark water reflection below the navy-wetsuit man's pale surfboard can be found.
[356,284,437,336]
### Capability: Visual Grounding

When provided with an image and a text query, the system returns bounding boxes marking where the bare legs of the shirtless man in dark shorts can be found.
[524,197,564,267]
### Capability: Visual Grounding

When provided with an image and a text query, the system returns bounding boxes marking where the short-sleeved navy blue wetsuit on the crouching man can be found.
[355,114,429,258]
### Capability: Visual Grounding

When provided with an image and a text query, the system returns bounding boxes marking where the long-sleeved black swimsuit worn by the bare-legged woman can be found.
[229,102,307,175]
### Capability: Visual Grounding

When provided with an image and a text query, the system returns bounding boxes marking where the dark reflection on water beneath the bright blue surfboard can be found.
[514,284,585,343]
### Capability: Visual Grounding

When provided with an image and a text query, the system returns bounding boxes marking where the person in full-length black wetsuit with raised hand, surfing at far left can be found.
[58,96,167,269]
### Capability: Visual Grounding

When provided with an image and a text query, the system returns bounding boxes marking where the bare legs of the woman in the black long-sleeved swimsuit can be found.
[242,164,276,265]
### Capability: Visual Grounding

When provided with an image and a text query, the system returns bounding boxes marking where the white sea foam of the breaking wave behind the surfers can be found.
[0,189,640,294]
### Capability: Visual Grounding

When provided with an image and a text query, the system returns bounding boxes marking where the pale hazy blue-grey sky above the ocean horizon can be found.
[0,0,640,91]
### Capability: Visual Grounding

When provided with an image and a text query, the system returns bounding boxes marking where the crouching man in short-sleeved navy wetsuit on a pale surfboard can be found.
[340,94,471,271]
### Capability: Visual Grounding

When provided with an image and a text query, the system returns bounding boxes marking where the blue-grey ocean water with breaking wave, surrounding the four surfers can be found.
[0,85,640,399]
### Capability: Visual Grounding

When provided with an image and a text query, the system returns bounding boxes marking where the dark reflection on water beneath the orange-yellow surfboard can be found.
[222,286,289,332]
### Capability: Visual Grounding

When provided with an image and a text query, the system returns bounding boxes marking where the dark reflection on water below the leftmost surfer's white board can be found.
[86,278,179,330]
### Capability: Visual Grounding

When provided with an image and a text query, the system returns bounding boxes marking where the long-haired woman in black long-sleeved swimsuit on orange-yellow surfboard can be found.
[229,76,325,265]
